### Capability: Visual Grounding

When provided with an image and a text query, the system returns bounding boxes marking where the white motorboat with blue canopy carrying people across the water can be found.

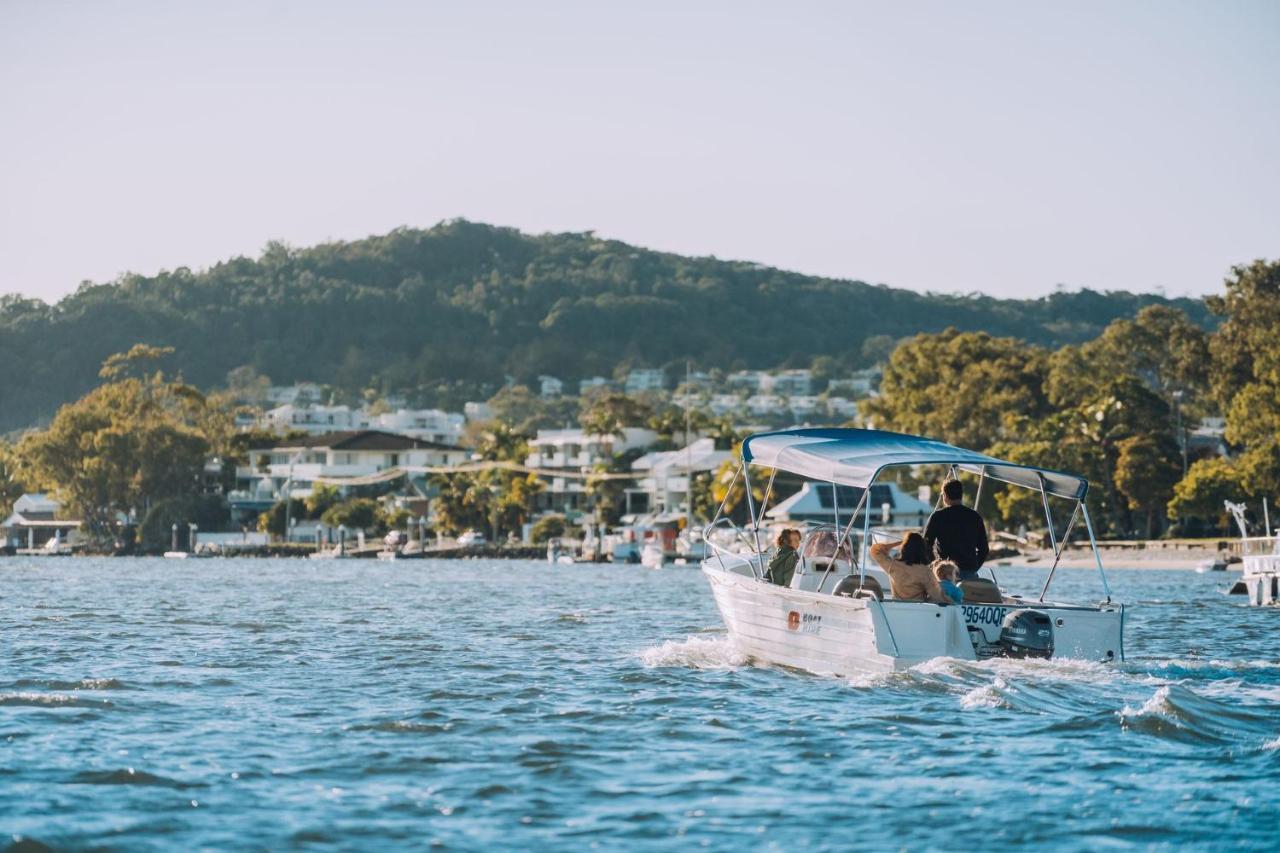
[703,429,1125,675]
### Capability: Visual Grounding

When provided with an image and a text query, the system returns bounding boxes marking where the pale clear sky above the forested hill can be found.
[0,0,1280,298]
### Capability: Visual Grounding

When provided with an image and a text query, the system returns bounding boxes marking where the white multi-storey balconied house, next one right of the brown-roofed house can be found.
[525,427,658,512]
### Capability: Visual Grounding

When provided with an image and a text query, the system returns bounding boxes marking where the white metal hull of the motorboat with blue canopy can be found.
[703,558,1124,675]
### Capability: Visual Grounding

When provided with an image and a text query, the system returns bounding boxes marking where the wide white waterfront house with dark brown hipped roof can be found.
[227,429,467,523]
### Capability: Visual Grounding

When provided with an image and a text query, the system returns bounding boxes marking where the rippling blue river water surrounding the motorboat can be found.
[0,558,1280,850]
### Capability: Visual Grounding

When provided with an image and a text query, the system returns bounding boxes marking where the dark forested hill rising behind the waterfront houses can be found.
[0,222,1210,432]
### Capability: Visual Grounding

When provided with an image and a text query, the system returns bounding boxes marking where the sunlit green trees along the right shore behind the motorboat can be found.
[864,260,1280,537]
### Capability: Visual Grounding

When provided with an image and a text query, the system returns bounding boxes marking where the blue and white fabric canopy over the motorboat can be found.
[742,429,1089,501]
